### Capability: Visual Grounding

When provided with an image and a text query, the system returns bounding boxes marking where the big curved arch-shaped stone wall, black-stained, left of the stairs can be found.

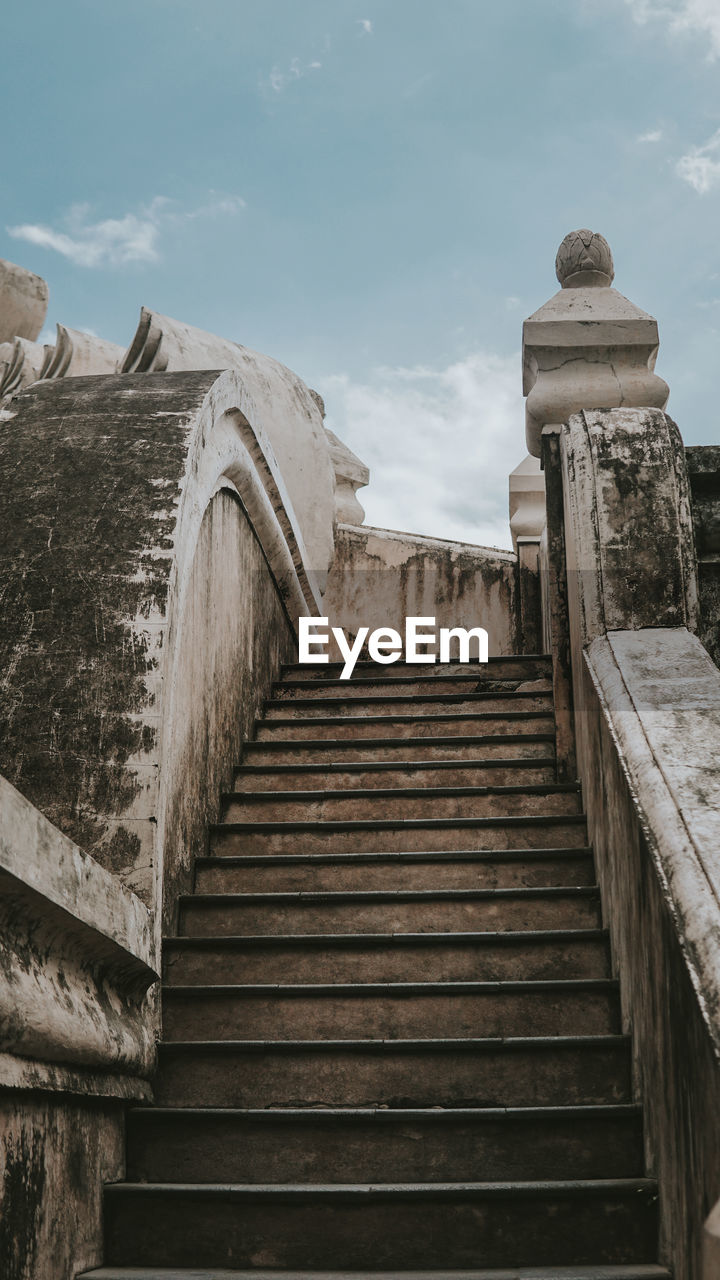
[0,371,316,921]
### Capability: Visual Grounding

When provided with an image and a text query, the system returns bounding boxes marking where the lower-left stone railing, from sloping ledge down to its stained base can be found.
[0,778,158,1280]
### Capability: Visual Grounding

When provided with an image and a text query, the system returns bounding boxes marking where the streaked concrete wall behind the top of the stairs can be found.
[323,525,519,657]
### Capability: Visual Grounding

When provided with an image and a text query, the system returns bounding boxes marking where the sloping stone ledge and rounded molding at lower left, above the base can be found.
[0,777,158,1097]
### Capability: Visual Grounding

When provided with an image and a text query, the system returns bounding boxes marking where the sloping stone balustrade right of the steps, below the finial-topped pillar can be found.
[575,628,720,1280]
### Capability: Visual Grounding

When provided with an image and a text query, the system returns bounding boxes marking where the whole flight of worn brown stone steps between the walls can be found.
[81,658,669,1280]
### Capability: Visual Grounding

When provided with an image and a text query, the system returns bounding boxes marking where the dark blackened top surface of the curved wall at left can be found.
[0,371,217,869]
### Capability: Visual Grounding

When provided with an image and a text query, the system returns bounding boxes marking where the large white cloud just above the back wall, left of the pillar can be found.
[319,351,527,548]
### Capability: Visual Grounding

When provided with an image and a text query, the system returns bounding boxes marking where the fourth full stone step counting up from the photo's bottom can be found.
[163,978,620,1041]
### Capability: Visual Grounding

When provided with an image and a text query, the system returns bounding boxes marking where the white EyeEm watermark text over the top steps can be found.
[299,618,488,680]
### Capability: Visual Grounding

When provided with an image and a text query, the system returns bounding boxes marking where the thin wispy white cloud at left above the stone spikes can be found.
[8,191,245,268]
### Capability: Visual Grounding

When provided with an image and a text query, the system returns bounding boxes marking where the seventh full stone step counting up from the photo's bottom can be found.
[195,847,594,893]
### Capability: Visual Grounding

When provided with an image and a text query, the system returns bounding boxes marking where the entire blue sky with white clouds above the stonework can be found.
[0,0,720,547]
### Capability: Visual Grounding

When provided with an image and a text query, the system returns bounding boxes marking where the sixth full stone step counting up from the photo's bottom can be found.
[181,886,602,937]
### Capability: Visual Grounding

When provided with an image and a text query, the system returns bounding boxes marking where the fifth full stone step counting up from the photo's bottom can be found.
[163,929,610,986]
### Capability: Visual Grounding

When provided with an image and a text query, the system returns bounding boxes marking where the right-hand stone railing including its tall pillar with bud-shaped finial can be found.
[525,233,720,1280]
